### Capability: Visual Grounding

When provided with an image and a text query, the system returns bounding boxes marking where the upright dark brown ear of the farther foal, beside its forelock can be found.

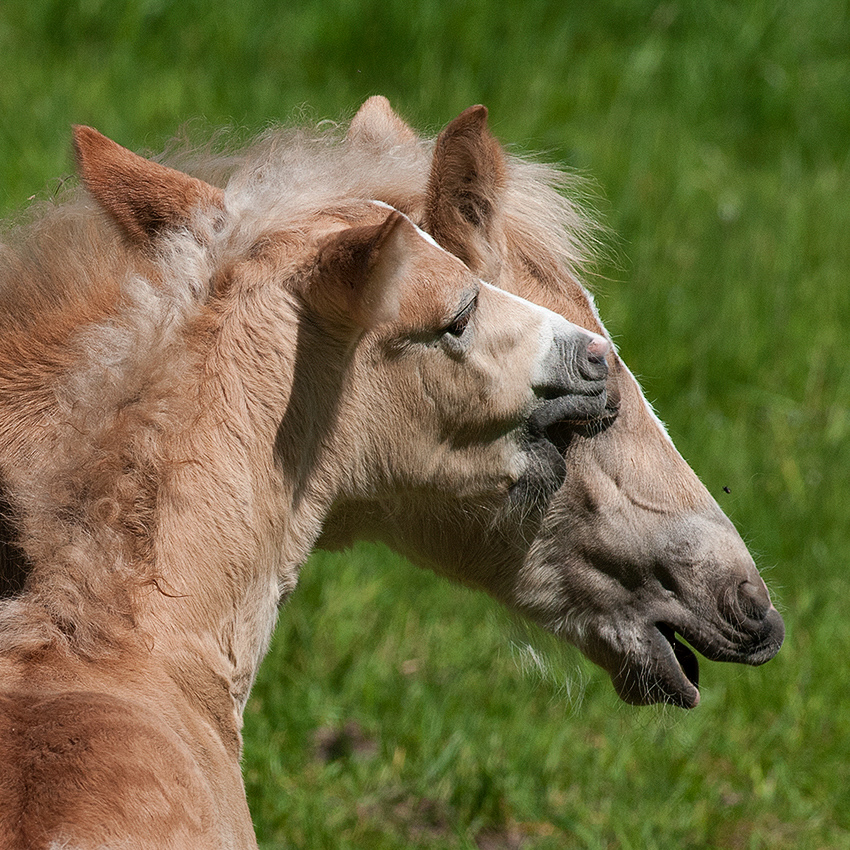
[425,106,506,270]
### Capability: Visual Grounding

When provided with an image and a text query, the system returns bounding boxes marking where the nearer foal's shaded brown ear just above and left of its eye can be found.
[312,210,418,329]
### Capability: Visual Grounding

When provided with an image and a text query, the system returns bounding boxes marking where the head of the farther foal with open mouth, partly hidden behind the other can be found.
[325,98,784,707]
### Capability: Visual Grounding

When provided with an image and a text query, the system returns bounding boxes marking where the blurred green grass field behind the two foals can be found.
[0,0,850,850]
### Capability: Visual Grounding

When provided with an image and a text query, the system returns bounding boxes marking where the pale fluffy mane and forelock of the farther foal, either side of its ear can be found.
[155,117,601,288]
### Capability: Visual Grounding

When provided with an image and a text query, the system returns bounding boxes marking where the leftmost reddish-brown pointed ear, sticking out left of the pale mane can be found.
[74,126,224,247]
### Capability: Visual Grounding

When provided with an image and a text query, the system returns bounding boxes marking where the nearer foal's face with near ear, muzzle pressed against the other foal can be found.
[302,202,610,505]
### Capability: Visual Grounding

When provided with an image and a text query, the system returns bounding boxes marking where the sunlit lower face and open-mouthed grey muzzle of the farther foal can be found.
[528,367,784,708]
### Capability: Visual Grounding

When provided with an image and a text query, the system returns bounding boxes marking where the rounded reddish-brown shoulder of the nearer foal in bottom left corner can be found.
[0,684,237,848]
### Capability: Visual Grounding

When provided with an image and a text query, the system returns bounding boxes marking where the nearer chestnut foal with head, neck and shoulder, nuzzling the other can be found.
[0,128,609,850]
